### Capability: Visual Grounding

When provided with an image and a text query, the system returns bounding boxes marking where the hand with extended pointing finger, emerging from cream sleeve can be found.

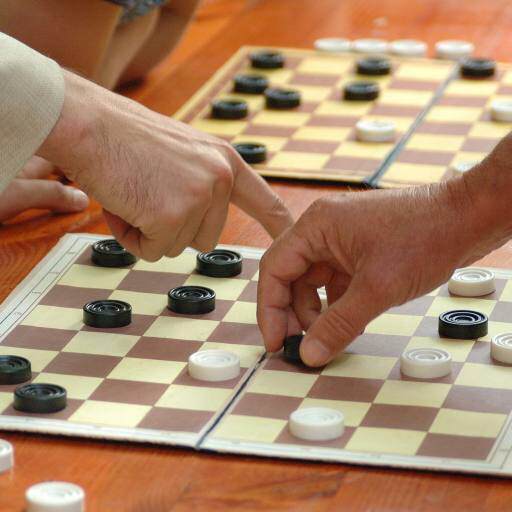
[39,72,292,261]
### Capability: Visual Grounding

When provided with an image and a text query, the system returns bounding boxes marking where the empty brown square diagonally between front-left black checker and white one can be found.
[89,379,169,405]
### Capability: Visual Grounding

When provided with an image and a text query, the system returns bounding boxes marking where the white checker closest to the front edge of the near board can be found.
[288,407,345,441]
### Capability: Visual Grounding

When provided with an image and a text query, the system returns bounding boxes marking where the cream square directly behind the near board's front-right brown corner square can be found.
[429,409,507,438]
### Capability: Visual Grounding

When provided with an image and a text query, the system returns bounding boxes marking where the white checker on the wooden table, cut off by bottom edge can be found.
[25,481,85,512]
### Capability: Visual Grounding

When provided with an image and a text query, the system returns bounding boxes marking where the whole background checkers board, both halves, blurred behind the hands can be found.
[175,47,512,188]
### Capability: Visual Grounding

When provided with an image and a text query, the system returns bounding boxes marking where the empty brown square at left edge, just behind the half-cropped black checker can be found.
[2,325,76,351]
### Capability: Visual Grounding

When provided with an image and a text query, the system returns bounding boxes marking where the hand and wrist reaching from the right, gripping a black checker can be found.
[257,136,512,366]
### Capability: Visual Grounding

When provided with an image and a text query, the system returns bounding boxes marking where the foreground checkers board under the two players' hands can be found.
[0,235,512,476]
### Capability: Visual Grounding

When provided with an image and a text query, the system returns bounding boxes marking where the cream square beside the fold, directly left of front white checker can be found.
[213,414,287,443]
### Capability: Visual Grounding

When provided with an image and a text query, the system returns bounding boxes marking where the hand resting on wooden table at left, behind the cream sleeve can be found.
[0,156,89,222]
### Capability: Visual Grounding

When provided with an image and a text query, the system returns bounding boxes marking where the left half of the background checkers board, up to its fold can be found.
[175,47,454,185]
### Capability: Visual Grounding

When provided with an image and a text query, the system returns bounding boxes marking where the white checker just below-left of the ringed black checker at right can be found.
[400,348,452,379]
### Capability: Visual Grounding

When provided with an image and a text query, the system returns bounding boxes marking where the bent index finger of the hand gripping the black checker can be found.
[257,229,311,351]
